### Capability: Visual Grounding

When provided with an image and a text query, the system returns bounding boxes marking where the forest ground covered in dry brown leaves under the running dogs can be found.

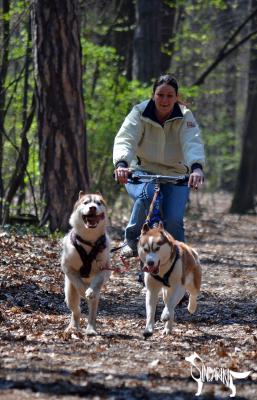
[0,193,257,400]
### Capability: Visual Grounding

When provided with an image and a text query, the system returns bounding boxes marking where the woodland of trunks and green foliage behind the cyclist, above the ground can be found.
[0,0,257,231]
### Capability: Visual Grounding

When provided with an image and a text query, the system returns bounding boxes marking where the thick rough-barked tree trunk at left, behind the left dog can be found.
[32,0,89,231]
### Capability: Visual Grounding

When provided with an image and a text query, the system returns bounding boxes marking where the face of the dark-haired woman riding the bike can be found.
[153,83,178,118]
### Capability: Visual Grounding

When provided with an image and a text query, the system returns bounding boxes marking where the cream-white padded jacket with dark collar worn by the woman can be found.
[113,100,205,175]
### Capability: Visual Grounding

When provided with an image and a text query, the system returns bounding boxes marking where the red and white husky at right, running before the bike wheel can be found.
[138,222,201,338]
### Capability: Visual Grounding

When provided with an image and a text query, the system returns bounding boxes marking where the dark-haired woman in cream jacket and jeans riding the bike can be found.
[113,74,204,257]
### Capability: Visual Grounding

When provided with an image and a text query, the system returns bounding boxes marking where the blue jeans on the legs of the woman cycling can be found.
[125,173,189,250]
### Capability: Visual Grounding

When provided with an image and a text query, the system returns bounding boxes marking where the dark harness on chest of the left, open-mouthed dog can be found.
[70,230,106,278]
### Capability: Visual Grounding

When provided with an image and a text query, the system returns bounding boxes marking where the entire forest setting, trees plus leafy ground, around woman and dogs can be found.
[0,0,257,400]
